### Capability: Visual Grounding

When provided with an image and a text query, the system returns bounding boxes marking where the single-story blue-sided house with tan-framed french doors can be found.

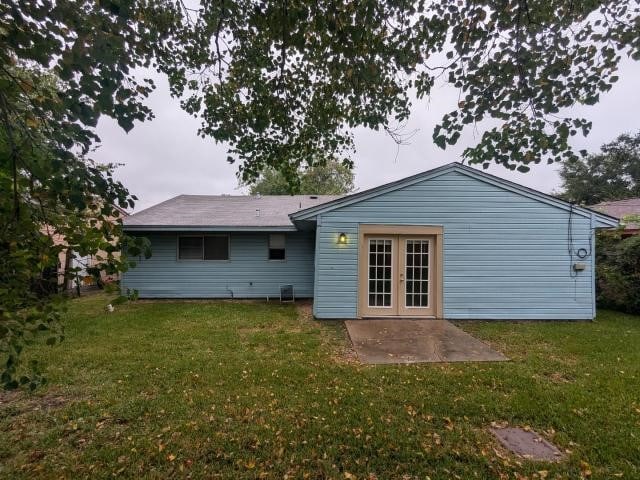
[122,163,618,320]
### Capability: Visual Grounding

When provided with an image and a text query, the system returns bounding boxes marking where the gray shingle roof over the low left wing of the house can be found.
[124,195,339,229]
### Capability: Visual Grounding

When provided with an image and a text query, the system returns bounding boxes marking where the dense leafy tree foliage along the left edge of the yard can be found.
[0,1,151,388]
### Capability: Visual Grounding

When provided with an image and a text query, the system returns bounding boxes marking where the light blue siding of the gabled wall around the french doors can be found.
[314,172,595,320]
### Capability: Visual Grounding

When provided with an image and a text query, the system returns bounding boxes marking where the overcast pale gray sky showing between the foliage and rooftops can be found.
[93,61,640,210]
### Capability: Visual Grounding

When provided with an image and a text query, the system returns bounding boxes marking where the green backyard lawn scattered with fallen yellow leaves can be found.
[0,295,640,479]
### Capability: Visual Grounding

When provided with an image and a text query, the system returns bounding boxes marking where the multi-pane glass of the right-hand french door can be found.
[405,240,429,308]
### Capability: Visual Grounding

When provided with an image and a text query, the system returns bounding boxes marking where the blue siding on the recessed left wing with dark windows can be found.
[122,232,314,298]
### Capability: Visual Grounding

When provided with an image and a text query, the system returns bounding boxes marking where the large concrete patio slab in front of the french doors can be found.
[345,318,508,364]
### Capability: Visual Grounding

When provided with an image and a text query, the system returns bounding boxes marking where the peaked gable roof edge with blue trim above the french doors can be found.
[289,162,619,227]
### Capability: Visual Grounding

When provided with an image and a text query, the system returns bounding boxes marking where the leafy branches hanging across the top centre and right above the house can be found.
[156,0,640,181]
